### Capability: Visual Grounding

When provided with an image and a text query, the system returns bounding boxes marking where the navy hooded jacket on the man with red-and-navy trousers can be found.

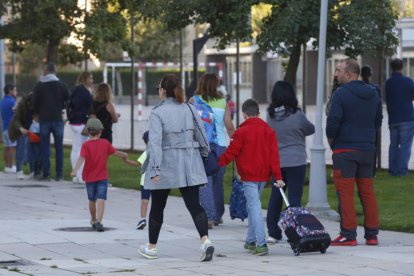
[326,80,382,150]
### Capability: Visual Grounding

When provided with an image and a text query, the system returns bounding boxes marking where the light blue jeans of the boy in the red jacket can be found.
[243,181,266,246]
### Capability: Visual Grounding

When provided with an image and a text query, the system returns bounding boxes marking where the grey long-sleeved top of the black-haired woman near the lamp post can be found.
[266,108,315,168]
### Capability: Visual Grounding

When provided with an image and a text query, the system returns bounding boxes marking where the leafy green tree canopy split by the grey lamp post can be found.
[257,0,398,84]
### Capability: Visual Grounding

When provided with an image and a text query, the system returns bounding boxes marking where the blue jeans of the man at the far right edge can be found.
[388,121,414,176]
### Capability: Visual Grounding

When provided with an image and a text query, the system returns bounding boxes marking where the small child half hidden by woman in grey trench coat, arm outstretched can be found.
[124,131,151,230]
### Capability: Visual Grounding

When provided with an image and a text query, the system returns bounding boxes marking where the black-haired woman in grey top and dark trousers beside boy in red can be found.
[266,81,315,244]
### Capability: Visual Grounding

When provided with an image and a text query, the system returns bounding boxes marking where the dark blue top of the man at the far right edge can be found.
[385,72,414,124]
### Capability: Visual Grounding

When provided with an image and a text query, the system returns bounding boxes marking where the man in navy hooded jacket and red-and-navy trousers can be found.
[326,59,382,246]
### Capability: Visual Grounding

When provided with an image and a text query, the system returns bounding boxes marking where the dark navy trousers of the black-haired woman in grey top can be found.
[266,165,306,240]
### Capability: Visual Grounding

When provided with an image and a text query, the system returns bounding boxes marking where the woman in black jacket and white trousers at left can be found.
[67,72,93,183]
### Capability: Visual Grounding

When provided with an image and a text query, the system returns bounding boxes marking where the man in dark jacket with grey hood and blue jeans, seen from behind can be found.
[32,63,69,181]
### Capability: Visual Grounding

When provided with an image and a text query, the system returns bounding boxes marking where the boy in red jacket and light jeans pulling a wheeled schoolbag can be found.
[219,99,285,256]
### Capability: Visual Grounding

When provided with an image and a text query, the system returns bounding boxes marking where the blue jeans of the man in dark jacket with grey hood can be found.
[40,121,64,178]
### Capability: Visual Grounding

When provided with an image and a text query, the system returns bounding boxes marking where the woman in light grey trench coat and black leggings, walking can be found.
[138,74,214,261]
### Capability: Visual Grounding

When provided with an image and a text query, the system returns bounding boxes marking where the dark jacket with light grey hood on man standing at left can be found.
[32,74,69,121]
